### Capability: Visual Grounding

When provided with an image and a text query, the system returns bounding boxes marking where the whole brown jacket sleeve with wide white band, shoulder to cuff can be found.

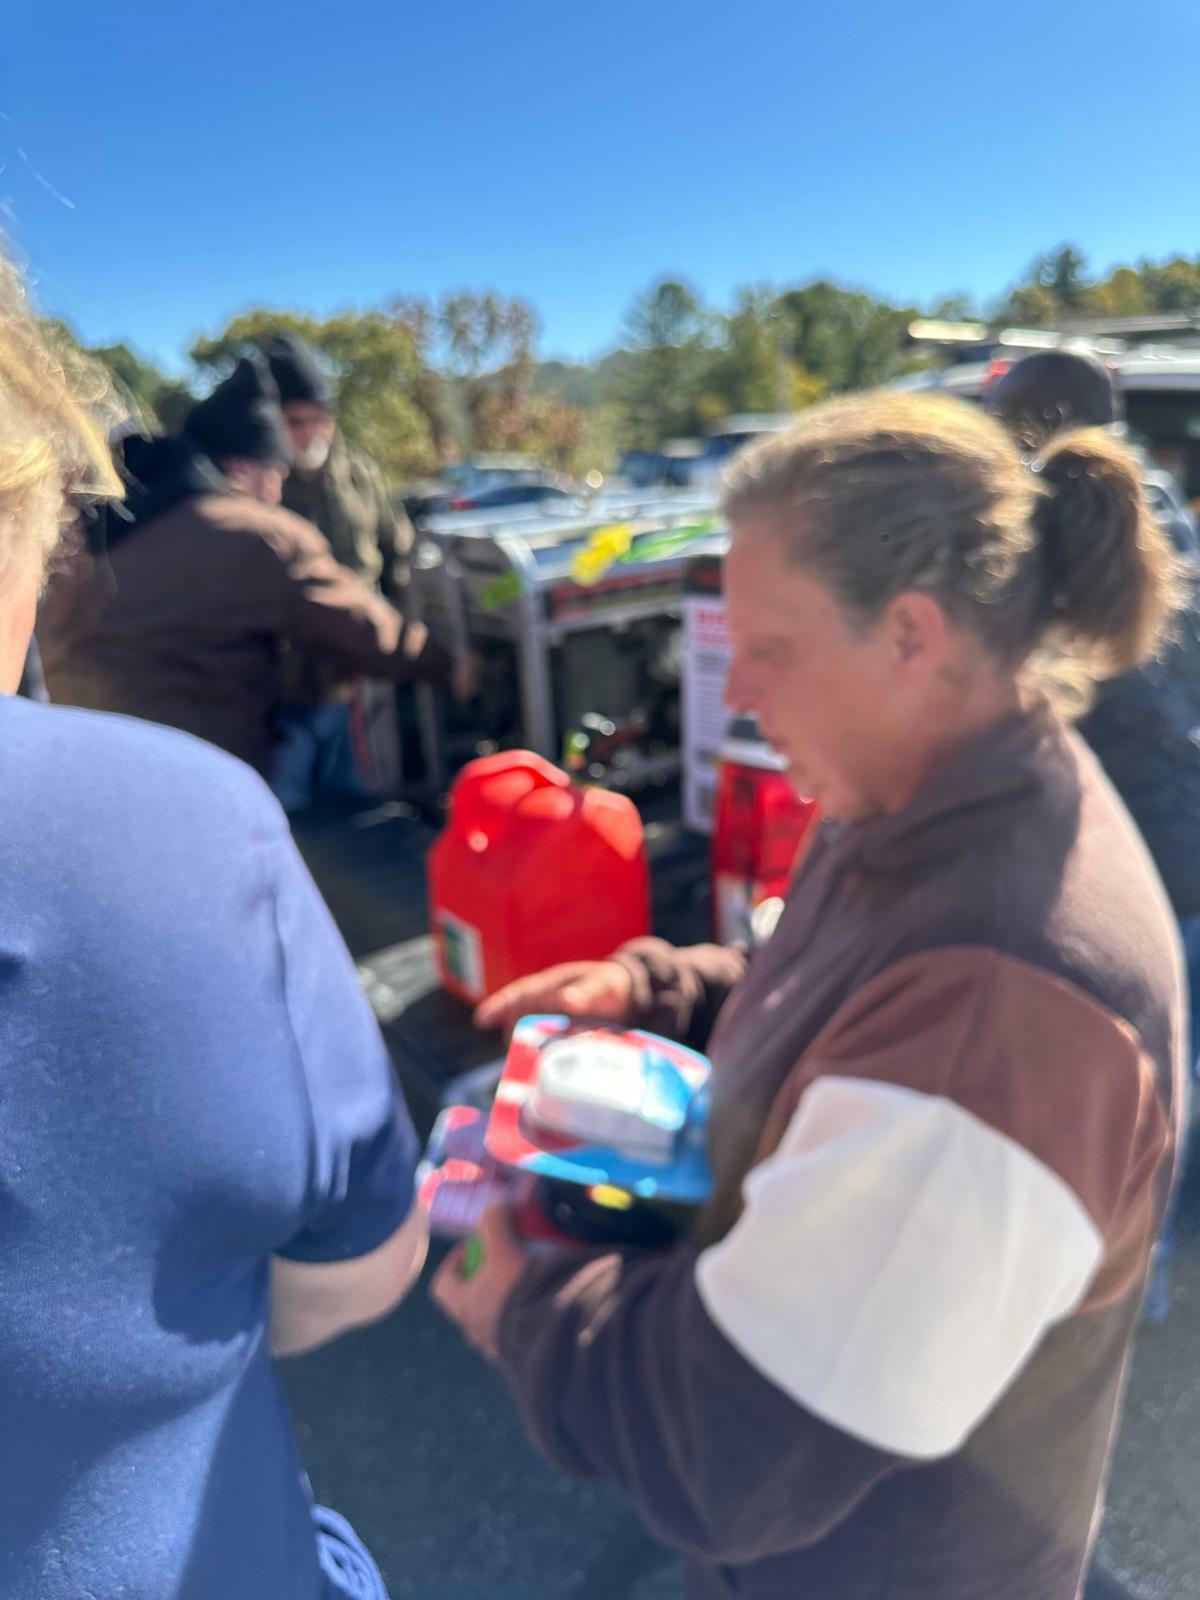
[501,949,1170,1565]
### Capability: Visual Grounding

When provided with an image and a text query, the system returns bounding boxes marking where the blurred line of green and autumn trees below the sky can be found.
[56,245,1200,485]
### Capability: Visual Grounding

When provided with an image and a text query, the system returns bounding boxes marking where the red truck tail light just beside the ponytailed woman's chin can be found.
[712,718,819,944]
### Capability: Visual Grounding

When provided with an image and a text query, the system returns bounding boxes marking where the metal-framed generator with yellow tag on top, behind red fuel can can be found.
[410,491,723,790]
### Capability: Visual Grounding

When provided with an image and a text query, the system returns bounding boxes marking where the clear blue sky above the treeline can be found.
[0,0,1200,365]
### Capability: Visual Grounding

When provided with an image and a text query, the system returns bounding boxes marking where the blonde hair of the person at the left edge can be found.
[0,256,123,581]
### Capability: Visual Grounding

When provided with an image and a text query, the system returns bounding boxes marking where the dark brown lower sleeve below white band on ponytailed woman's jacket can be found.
[499,1246,902,1565]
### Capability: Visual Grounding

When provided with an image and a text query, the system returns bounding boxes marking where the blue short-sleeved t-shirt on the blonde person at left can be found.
[0,699,416,1600]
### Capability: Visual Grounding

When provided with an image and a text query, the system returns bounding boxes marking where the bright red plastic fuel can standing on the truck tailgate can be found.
[429,750,650,1002]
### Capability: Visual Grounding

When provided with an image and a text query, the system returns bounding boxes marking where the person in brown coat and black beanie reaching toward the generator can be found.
[38,360,454,787]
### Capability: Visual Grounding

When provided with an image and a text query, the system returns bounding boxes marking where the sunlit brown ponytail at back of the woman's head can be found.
[1032,429,1179,675]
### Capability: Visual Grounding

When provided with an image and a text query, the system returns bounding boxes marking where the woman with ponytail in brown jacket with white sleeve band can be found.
[437,397,1182,1600]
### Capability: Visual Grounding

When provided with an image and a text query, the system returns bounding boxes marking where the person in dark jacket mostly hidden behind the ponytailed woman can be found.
[987,350,1200,1322]
